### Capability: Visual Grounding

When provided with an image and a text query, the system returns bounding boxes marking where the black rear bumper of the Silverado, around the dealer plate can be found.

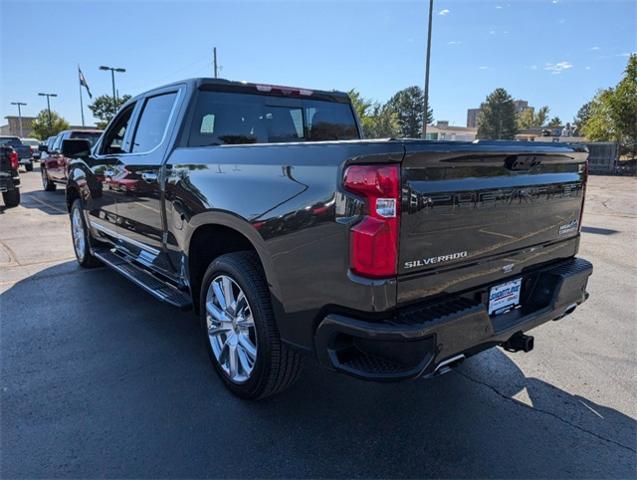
[315,258,593,381]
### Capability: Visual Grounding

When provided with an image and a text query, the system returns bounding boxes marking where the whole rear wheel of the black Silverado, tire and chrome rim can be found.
[200,252,301,399]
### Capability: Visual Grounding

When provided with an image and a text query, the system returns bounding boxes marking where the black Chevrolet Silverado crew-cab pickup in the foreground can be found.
[62,79,592,398]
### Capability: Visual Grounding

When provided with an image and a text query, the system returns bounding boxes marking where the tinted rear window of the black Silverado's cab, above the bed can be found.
[189,91,358,146]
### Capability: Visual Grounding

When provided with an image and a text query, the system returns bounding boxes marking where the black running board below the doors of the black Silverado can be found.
[93,249,192,310]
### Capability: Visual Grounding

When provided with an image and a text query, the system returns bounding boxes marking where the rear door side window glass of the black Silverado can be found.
[132,92,176,152]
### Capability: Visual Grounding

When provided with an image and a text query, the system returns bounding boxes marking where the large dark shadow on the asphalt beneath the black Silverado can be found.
[0,262,637,478]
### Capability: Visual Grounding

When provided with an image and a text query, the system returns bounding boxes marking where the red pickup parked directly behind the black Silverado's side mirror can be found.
[40,129,102,192]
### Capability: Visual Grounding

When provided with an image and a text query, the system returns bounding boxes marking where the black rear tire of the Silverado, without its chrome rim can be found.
[199,251,302,399]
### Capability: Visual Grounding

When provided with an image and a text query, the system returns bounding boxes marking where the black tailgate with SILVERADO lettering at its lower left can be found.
[398,141,587,275]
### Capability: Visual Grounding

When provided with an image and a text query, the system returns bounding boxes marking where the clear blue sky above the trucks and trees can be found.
[0,0,637,125]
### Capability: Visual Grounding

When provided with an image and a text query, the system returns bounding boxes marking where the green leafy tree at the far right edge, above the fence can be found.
[583,54,637,158]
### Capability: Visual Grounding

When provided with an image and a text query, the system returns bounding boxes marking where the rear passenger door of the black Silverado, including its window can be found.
[113,87,182,275]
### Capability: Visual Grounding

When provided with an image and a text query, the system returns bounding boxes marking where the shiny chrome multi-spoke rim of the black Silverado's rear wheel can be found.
[206,275,257,383]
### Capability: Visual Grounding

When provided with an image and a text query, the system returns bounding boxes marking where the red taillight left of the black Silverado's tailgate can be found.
[343,165,400,278]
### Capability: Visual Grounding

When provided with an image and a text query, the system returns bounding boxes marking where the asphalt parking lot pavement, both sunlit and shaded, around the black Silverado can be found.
[0,167,637,478]
